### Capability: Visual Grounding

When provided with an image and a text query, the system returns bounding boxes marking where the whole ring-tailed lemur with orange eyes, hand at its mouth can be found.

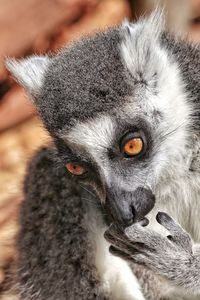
[7,14,200,300]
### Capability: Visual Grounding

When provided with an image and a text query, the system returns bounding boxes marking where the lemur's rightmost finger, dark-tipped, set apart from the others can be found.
[156,212,192,252]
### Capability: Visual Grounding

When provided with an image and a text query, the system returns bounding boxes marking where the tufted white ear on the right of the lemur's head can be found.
[121,7,166,86]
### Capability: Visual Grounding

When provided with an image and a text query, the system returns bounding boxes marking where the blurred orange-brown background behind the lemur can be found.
[0,0,200,300]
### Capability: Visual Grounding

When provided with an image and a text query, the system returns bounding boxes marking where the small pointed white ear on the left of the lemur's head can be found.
[6,56,50,98]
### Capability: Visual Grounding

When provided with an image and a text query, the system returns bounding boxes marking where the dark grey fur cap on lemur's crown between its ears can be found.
[36,29,132,133]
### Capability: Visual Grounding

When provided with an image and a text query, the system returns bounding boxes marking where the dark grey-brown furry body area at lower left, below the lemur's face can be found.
[18,149,108,300]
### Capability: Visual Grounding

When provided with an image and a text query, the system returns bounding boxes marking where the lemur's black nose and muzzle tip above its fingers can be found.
[106,187,155,227]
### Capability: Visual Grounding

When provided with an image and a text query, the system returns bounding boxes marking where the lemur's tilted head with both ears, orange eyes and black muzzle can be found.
[7,14,189,225]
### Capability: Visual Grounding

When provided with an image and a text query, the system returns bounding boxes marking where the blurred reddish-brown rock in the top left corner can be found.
[0,0,96,60]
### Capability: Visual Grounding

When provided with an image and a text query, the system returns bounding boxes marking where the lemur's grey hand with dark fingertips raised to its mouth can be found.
[105,212,193,280]
